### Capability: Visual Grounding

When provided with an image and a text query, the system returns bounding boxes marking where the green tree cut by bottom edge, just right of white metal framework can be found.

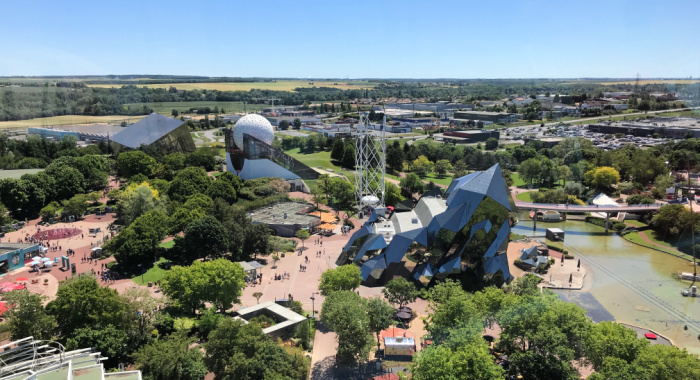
[134,332,207,380]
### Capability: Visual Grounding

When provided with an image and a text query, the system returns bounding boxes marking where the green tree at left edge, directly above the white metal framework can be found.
[2,290,56,340]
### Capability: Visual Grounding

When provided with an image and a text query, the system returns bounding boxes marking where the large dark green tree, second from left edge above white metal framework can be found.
[46,276,129,337]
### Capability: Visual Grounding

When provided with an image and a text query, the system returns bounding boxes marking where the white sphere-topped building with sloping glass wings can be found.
[224,114,318,185]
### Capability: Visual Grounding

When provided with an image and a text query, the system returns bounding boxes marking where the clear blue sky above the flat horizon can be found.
[0,0,700,78]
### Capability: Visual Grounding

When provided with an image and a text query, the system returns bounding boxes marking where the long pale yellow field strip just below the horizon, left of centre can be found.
[88,80,376,91]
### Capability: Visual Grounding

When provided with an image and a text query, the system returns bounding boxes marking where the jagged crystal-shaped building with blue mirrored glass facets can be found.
[337,165,512,286]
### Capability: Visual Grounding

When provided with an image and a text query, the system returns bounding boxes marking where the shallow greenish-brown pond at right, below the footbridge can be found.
[513,213,700,354]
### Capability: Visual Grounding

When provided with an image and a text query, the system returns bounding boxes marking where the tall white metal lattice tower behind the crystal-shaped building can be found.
[355,114,386,209]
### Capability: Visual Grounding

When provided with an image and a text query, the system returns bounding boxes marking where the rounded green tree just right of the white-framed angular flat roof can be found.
[321,290,372,364]
